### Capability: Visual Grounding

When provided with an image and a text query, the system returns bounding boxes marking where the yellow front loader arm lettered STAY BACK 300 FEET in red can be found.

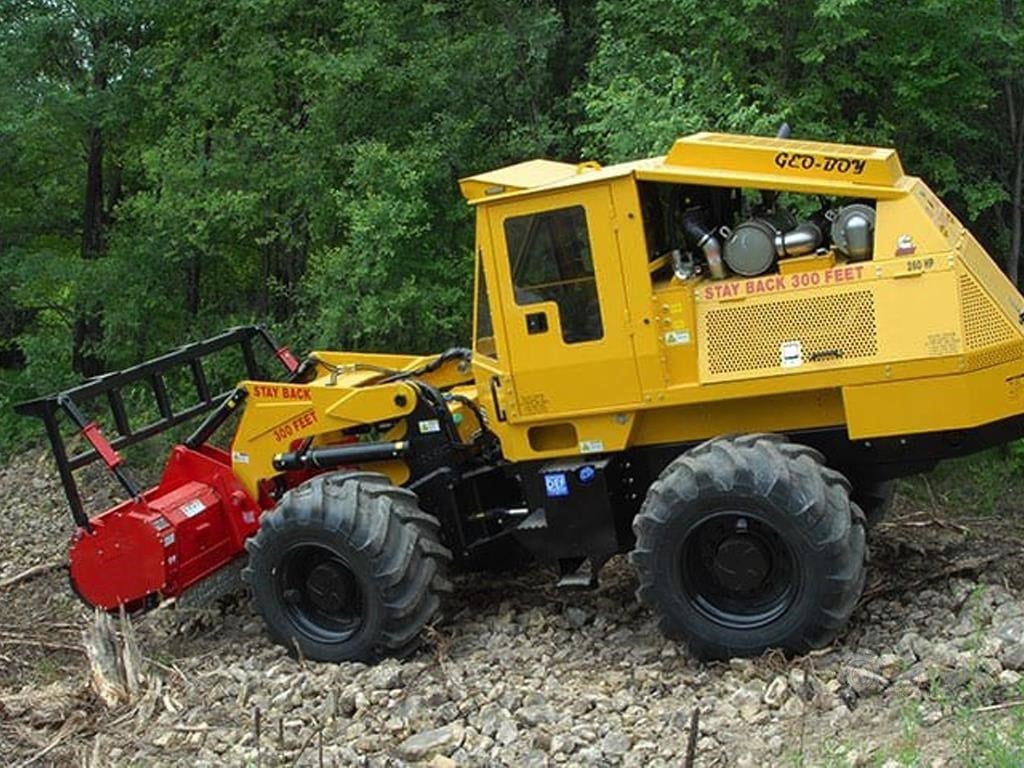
[231,350,482,498]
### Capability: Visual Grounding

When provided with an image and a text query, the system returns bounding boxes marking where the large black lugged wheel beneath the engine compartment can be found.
[630,434,865,658]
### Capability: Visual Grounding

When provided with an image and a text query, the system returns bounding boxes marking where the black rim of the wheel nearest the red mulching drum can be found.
[278,544,367,643]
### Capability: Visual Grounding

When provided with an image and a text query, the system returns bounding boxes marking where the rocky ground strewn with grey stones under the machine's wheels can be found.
[0,455,1024,768]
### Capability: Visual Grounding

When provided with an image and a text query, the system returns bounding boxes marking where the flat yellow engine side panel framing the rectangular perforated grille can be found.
[694,260,963,383]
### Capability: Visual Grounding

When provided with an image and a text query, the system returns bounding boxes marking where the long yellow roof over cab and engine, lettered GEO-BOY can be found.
[459,132,913,205]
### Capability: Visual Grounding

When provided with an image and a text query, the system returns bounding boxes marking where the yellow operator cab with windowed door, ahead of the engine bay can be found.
[463,164,640,428]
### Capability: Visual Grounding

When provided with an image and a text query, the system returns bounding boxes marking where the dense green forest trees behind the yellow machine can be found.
[0,0,1024,460]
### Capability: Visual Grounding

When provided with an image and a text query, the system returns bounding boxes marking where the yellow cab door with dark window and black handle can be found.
[488,185,640,421]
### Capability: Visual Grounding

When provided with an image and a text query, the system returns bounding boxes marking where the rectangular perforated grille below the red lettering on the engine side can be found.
[701,291,878,376]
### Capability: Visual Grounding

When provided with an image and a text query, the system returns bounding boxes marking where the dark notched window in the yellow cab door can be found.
[505,206,604,344]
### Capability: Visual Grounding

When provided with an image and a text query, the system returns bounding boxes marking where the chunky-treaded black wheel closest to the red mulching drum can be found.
[242,472,452,663]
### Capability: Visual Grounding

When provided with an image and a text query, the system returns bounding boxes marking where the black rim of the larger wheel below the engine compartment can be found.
[679,511,801,630]
